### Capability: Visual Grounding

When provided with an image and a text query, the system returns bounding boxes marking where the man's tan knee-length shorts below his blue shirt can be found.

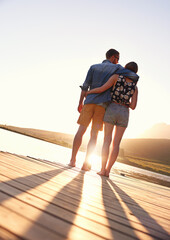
[77,104,105,131]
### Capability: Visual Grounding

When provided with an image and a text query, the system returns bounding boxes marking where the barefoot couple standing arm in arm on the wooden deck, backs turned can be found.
[69,49,139,177]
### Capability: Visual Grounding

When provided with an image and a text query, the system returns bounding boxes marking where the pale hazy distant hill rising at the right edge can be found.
[139,123,170,139]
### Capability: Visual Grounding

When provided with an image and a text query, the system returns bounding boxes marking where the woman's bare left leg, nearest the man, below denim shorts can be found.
[98,122,114,175]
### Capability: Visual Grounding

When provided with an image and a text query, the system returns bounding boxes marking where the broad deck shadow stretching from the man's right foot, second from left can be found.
[24,172,84,239]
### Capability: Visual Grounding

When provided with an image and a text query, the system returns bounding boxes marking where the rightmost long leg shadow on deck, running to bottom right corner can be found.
[106,179,169,240]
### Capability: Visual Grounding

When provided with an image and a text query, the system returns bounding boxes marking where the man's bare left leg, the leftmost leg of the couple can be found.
[69,125,87,167]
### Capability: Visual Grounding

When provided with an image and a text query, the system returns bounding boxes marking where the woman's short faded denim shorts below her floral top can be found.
[104,102,129,128]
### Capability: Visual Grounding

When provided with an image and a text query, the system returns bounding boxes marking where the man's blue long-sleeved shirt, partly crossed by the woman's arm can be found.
[81,60,139,104]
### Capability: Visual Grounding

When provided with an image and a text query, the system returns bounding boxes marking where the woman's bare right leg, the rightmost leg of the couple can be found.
[105,126,126,177]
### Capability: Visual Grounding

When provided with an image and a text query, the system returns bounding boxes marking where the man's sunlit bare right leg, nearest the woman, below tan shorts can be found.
[81,129,99,171]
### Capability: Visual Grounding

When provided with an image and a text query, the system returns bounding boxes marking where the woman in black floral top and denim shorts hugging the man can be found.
[87,62,138,177]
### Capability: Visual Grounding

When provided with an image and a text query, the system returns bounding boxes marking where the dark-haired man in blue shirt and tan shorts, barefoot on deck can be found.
[69,49,139,171]
